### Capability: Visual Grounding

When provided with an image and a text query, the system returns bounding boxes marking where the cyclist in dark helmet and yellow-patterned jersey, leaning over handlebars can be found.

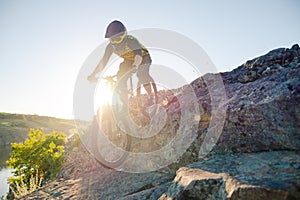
[88,20,157,104]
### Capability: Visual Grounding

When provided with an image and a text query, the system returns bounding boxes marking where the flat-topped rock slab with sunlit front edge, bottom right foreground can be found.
[159,151,300,200]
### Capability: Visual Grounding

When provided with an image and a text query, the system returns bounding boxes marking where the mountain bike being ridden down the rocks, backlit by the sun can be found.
[89,73,157,168]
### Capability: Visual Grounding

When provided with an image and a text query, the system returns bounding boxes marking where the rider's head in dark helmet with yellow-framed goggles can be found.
[105,20,127,44]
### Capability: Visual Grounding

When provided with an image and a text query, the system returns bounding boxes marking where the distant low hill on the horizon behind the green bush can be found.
[0,112,75,146]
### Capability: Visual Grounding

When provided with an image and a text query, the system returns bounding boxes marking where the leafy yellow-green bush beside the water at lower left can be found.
[7,129,66,196]
